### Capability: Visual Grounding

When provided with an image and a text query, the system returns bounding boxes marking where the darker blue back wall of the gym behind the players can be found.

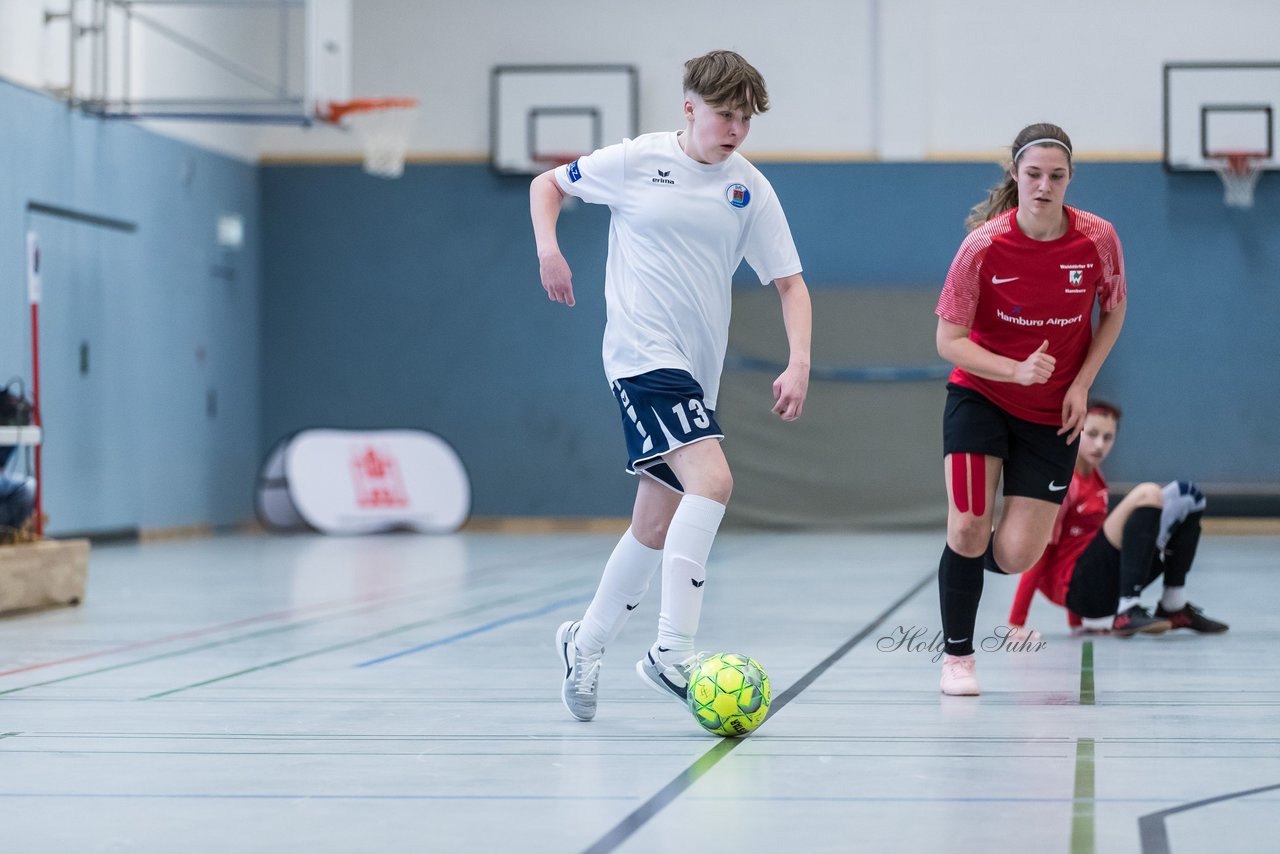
[261,163,1280,515]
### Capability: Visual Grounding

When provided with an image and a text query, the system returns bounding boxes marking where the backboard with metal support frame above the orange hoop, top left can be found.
[45,0,352,124]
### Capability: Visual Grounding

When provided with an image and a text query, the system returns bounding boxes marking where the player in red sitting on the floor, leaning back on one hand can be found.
[1009,401,1228,639]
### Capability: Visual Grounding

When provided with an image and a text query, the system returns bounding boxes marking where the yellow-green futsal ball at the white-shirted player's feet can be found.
[689,653,769,736]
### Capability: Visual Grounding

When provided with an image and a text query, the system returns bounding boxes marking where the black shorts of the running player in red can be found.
[942,383,1080,504]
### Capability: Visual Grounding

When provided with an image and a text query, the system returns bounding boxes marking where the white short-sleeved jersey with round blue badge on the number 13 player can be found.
[556,132,801,408]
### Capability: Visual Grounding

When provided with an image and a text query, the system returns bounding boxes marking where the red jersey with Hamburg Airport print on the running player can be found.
[937,207,1125,424]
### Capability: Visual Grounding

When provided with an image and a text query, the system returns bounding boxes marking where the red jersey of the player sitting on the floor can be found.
[1009,469,1111,626]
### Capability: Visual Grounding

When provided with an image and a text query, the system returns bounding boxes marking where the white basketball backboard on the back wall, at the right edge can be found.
[1165,63,1280,172]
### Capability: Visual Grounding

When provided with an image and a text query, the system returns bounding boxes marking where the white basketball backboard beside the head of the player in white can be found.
[489,65,640,175]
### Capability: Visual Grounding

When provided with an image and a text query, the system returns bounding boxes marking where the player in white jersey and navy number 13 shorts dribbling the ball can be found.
[530,51,812,721]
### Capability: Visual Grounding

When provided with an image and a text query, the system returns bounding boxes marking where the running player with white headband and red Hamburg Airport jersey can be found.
[937,124,1125,694]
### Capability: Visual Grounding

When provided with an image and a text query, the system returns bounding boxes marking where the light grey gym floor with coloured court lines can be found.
[0,531,1280,854]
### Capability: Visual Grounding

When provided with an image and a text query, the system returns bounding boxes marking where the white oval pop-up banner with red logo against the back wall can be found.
[257,429,471,534]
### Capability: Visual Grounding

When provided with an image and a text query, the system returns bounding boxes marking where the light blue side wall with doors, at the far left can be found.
[0,82,262,534]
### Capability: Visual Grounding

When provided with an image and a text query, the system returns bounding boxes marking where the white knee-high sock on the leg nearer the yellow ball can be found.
[658,495,724,662]
